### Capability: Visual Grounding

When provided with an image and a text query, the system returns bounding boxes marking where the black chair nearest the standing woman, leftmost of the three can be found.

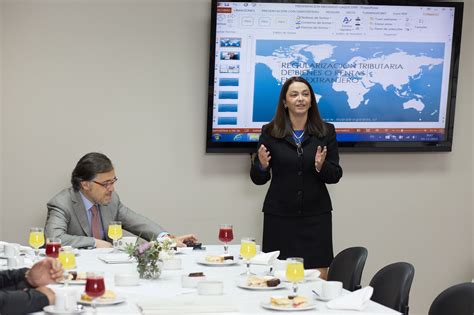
[328,247,368,291]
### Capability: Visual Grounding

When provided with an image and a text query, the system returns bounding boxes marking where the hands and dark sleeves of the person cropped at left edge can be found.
[0,258,63,315]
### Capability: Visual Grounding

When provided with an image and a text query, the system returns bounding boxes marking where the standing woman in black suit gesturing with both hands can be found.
[250,77,342,279]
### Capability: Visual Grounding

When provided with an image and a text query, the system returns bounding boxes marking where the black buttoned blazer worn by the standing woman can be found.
[250,123,342,216]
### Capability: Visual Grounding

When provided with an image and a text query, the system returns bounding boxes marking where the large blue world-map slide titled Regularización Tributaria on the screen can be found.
[252,39,446,126]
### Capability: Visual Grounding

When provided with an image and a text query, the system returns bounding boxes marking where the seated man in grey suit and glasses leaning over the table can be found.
[44,152,197,248]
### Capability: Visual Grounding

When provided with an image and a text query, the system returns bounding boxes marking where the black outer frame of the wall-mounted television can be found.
[206,0,464,153]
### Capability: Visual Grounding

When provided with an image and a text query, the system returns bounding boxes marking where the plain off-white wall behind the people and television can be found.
[0,0,474,314]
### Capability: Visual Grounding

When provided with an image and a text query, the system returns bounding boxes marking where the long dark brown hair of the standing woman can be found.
[266,77,327,139]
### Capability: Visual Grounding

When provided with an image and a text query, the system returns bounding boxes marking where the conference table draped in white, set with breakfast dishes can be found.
[29,245,399,315]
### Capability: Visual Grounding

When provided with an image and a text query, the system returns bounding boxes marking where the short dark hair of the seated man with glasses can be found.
[71,152,114,191]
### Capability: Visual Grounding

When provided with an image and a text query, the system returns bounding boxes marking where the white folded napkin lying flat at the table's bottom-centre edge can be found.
[137,296,239,314]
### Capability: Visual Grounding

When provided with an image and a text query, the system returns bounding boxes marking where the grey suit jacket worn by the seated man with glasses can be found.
[44,187,164,248]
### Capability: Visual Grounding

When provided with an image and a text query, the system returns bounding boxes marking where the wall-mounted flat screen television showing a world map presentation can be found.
[206,0,463,153]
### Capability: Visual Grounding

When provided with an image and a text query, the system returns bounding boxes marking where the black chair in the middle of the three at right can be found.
[369,262,415,315]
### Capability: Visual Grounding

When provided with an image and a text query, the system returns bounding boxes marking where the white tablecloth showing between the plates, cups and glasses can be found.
[30,245,399,315]
